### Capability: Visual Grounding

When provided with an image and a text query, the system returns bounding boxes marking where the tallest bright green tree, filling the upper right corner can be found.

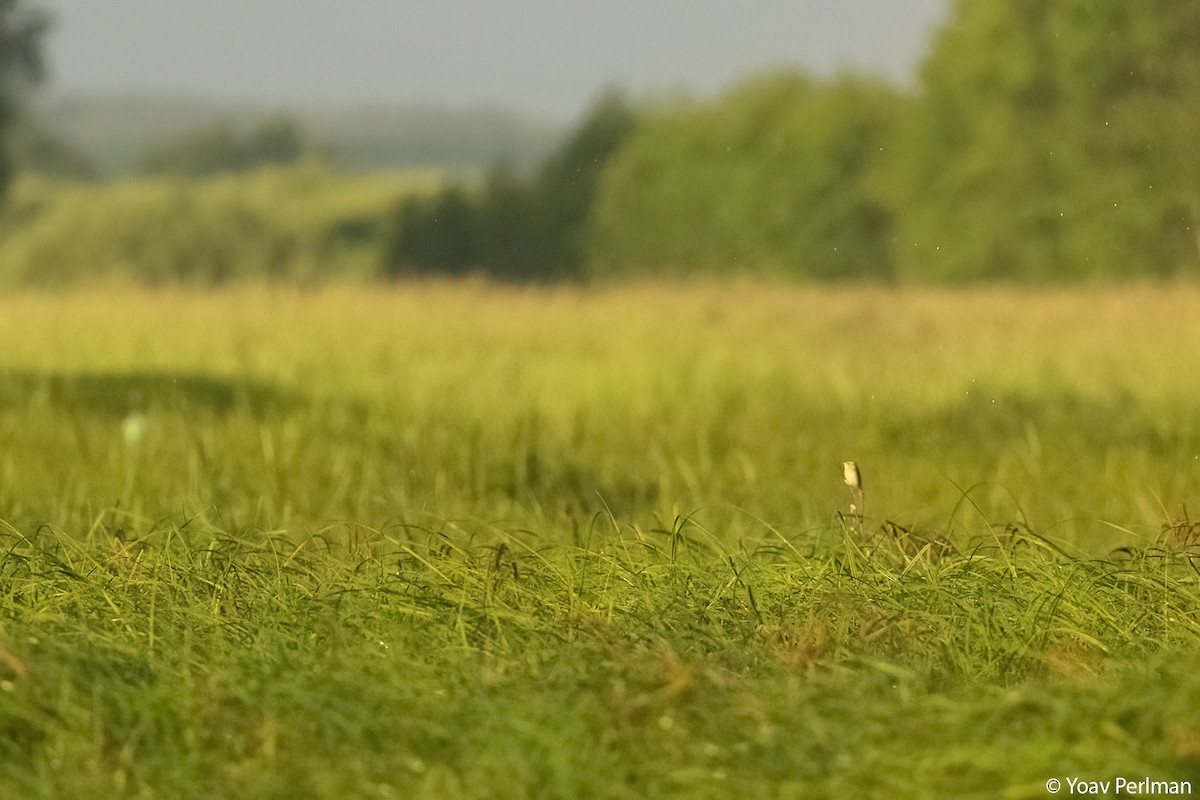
[884,0,1200,279]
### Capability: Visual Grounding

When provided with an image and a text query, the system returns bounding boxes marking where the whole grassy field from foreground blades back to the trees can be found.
[0,283,1200,799]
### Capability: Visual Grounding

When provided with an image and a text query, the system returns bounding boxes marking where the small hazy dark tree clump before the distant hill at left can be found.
[142,114,314,176]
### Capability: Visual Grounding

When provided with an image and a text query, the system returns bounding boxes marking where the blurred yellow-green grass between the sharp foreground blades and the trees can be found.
[0,284,1200,544]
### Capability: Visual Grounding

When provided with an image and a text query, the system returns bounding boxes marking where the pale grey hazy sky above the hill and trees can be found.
[41,0,948,119]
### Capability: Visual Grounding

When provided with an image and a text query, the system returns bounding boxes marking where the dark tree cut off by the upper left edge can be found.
[0,0,49,193]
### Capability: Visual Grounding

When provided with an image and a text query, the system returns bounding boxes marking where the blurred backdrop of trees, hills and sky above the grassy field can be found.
[0,0,1200,285]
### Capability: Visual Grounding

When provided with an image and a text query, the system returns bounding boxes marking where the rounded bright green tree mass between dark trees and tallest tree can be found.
[592,73,902,278]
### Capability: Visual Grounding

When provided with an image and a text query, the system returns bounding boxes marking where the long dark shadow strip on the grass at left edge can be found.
[0,372,302,416]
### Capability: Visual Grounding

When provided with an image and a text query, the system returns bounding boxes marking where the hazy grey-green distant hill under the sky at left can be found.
[37,95,564,178]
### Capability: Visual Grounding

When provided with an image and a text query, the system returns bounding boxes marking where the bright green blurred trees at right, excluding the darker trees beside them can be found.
[592,0,1200,282]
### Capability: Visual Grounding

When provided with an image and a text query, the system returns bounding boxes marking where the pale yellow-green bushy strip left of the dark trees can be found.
[0,162,439,285]
